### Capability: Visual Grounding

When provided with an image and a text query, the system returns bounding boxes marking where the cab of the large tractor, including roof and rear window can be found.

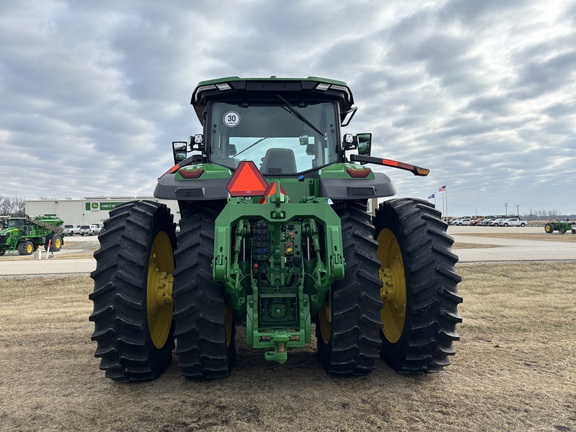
[175,77,372,177]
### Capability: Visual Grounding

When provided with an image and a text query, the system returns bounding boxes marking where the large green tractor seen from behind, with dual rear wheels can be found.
[90,77,462,381]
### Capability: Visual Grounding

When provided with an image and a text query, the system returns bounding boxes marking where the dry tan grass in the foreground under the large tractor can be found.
[0,262,576,431]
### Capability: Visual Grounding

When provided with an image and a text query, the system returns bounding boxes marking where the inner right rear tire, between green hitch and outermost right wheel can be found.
[316,201,382,376]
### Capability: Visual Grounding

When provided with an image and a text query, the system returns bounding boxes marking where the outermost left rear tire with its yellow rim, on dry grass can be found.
[89,201,176,381]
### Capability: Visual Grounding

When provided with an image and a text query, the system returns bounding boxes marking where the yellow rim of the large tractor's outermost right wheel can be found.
[376,228,406,343]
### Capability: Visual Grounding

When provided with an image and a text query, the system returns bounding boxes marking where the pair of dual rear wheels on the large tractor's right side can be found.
[316,199,462,375]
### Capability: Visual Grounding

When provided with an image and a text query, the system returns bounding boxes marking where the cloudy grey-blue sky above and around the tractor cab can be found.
[0,0,576,216]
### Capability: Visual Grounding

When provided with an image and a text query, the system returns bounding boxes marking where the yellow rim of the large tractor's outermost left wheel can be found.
[146,231,174,349]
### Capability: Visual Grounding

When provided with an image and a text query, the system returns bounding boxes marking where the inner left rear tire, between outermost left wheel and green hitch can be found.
[174,205,236,379]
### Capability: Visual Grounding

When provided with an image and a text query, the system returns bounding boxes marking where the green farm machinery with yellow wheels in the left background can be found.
[0,215,64,256]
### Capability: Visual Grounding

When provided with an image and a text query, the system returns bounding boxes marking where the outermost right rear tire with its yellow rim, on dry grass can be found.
[374,199,462,374]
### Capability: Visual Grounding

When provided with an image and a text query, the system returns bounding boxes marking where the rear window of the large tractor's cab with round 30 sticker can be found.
[205,99,340,176]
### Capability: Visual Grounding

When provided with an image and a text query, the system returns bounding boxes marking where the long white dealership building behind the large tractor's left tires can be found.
[25,197,180,225]
